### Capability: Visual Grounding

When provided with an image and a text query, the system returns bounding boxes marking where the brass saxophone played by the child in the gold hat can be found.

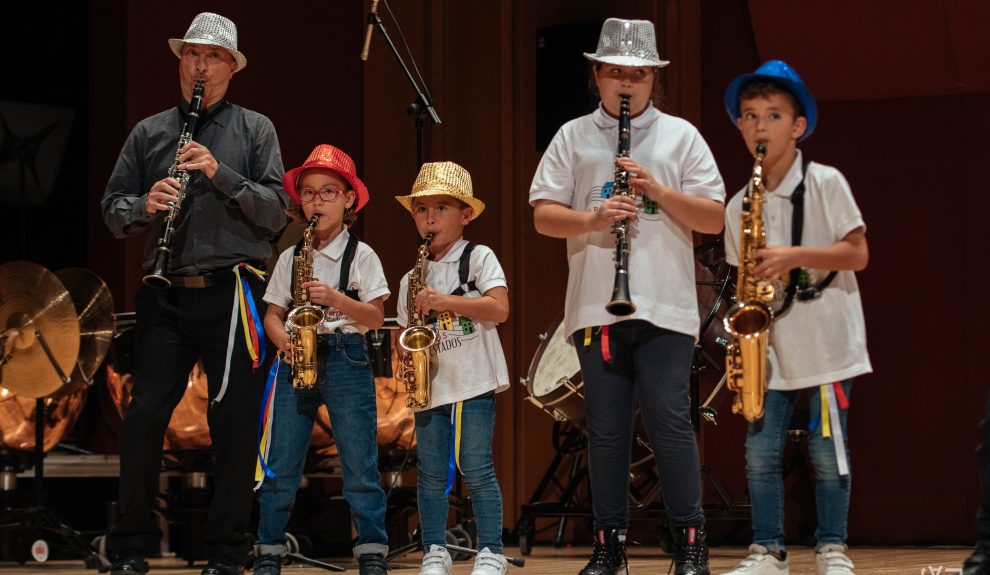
[399,234,438,408]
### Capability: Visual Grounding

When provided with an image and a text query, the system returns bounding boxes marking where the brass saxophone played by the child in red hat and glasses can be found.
[287,215,326,389]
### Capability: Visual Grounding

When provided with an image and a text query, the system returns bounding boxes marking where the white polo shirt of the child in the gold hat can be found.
[396,238,509,410]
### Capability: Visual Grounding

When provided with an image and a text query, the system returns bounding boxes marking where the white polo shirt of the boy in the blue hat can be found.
[725,150,873,390]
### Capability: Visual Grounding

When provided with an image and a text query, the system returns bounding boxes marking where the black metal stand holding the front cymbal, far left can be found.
[0,329,110,571]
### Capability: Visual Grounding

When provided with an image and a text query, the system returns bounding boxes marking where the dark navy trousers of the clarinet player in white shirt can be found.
[572,320,705,529]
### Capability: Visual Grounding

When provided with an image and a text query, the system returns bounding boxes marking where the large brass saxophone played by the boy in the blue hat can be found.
[723,142,774,421]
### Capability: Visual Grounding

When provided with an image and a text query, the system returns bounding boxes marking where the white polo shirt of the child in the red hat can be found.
[264,225,390,333]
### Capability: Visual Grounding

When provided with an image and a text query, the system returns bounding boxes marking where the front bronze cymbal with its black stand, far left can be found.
[0,261,112,569]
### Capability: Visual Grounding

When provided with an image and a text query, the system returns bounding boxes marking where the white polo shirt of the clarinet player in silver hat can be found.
[529,106,725,341]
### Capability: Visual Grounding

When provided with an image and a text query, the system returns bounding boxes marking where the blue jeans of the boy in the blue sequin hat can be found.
[746,379,852,551]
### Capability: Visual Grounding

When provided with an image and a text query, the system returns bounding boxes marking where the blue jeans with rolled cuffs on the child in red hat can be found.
[258,333,388,557]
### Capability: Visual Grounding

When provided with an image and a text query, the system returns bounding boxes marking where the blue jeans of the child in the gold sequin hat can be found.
[416,392,502,553]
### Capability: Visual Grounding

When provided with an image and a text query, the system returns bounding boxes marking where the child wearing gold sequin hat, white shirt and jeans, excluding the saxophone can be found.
[396,162,509,575]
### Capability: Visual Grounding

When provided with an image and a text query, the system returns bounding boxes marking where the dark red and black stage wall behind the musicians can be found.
[0,0,990,544]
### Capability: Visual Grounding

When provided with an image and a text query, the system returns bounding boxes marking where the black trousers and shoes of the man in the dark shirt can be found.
[107,274,270,563]
